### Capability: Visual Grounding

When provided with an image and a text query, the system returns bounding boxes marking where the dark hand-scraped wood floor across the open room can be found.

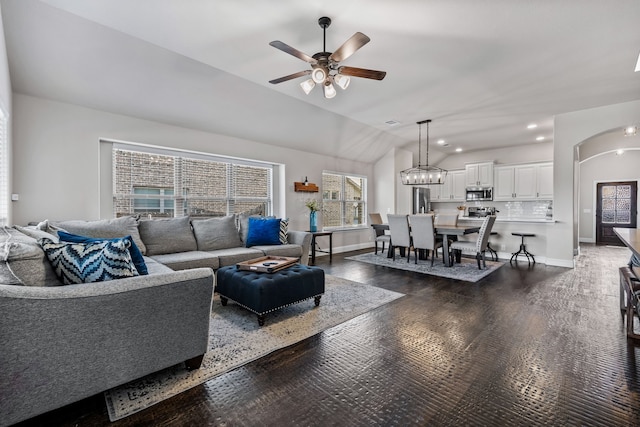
[13,245,640,427]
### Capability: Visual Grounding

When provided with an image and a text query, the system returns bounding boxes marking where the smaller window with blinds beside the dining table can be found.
[322,172,367,228]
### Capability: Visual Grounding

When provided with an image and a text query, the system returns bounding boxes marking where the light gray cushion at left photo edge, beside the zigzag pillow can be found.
[0,227,62,286]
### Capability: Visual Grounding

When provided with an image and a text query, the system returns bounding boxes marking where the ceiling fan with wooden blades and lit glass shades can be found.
[269,16,387,98]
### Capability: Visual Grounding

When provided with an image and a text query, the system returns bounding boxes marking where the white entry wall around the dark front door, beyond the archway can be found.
[578,150,640,242]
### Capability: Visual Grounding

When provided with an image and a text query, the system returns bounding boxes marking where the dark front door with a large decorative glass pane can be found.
[596,181,638,246]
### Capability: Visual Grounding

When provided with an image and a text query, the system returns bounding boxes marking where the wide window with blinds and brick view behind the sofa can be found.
[112,144,273,218]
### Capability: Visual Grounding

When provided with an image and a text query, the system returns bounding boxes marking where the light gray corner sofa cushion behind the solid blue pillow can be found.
[53,216,147,254]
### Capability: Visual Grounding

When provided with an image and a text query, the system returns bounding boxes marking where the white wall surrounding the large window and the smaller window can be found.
[13,94,374,251]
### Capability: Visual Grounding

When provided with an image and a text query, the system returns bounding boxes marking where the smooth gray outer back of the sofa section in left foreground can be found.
[0,268,214,425]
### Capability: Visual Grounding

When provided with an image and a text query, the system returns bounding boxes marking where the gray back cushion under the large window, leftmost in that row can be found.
[138,216,198,256]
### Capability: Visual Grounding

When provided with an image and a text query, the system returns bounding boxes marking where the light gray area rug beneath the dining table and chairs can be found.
[345,252,504,282]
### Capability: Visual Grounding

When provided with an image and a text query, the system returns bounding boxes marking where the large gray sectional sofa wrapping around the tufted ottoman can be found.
[0,215,311,425]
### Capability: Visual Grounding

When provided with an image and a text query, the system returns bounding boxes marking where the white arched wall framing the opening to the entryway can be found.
[547,101,640,263]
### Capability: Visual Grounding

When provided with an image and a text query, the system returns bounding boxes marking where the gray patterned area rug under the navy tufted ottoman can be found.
[104,275,404,421]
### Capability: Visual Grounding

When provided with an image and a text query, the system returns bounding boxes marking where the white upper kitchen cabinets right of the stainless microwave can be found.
[493,163,553,200]
